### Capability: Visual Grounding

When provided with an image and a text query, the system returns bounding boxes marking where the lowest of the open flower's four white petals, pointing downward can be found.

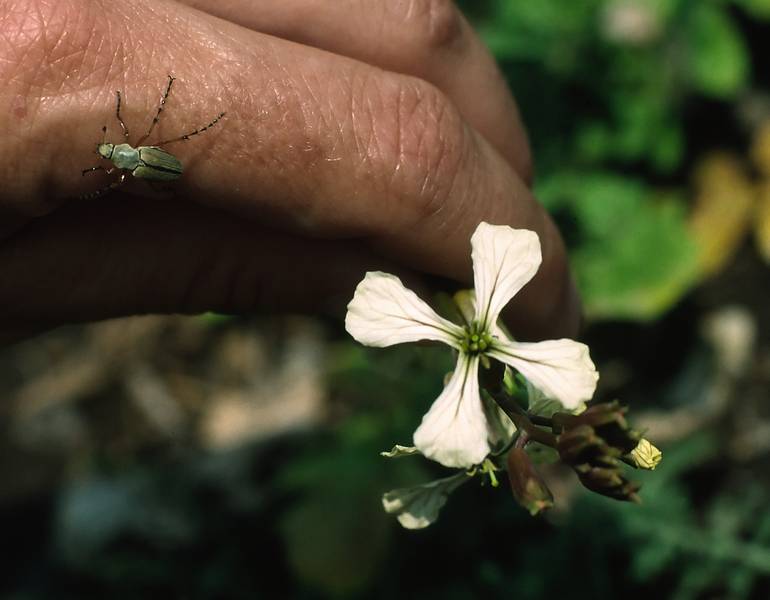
[414,354,489,468]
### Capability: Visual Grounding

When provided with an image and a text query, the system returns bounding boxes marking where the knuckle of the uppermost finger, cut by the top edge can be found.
[390,0,462,55]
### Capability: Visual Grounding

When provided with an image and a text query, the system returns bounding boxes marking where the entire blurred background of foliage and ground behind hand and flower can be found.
[0,0,770,600]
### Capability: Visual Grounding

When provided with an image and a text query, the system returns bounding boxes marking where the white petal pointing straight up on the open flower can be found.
[471,223,543,329]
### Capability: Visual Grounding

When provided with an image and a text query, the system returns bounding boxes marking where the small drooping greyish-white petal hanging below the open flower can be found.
[382,473,470,529]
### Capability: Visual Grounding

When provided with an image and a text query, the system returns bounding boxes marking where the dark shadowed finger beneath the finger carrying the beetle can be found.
[0,195,404,337]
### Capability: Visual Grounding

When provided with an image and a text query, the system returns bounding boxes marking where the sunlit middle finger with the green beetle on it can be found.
[0,0,569,338]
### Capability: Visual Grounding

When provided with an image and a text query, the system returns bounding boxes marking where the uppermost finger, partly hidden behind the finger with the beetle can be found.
[177,0,532,183]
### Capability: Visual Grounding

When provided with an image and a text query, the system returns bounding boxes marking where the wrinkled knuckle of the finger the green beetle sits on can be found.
[364,78,469,222]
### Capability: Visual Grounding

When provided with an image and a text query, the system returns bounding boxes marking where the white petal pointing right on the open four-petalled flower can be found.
[487,339,599,409]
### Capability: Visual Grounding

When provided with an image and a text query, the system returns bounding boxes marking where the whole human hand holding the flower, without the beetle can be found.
[0,0,578,339]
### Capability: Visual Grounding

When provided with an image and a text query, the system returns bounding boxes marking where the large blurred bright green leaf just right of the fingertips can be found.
[538,172,698,319]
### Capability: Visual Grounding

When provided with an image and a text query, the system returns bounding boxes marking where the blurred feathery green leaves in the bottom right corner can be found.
[604,434,770,600]
